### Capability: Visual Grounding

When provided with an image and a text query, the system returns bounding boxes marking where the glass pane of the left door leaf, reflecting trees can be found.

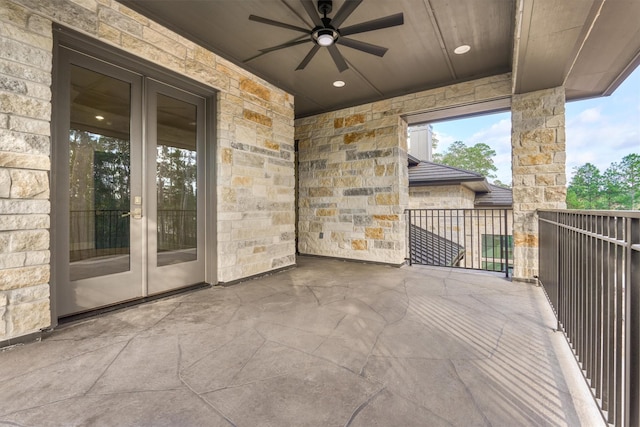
[69,65,131,281]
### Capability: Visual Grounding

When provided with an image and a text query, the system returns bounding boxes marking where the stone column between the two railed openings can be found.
[511,86,567,281]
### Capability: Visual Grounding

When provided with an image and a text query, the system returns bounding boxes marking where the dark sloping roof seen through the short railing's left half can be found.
[410,224,464,267]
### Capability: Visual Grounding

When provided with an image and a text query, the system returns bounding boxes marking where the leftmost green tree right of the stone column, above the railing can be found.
[567,163,604,209]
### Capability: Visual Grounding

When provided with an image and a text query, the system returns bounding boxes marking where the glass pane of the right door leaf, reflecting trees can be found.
[156,94,197,266]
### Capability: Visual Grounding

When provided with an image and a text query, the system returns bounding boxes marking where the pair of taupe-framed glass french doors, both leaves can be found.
[54,46,206,316]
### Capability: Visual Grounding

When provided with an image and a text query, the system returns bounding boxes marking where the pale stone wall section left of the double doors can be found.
[0,1,53,341]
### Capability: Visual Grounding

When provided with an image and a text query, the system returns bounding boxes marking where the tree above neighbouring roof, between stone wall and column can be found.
[433,141,498,178]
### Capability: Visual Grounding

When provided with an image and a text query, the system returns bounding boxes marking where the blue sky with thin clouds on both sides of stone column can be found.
[433,67,640,183]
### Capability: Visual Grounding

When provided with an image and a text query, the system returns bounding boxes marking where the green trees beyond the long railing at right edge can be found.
[567,154,640,210]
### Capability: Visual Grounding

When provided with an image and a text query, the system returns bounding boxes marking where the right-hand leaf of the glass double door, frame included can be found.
[146,81,205,294]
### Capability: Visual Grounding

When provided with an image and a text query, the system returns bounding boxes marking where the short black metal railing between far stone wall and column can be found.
[405,209,513,277]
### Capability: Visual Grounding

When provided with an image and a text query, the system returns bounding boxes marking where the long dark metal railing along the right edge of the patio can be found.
[538,210,640,426]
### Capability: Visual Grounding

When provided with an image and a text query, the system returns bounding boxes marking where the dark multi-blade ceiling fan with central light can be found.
[245,0,404,72]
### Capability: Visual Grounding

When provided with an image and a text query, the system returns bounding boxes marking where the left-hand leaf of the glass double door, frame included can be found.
[54,48,144,316]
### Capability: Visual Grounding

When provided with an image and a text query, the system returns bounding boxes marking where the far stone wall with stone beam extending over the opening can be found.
[296,74,511,264]
